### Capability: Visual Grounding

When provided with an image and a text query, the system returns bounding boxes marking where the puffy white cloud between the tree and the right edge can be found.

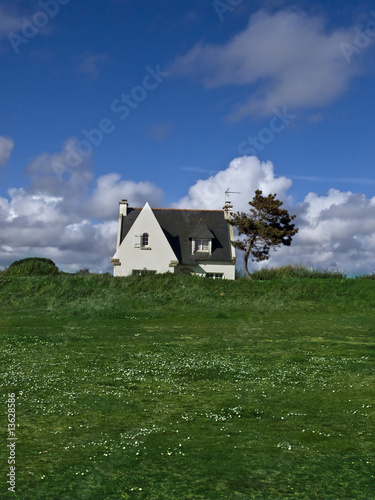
[272,189,375,274]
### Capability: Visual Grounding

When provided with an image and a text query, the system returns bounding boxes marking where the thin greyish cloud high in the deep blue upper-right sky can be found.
[171,10,358,119]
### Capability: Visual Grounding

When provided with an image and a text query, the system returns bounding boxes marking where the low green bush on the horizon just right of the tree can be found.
[251,264,346,280]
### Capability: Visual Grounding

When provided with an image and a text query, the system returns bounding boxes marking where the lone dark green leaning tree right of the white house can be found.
[230,189,298,276]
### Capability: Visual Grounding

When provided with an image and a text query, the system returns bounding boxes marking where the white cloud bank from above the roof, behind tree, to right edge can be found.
[174,156,375,274]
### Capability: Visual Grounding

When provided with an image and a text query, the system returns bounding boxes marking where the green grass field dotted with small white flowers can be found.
[0,275,375,500]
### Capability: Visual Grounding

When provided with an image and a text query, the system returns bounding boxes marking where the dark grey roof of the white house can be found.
[121,208,232,265]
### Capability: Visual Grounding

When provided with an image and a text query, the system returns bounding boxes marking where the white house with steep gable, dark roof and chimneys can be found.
[111,200,236,279]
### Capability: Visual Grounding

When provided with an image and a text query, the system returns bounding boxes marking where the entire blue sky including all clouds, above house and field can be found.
[0,0,375,273]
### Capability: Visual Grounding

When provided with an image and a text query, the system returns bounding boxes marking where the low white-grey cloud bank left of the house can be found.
[0,139,163,272]
